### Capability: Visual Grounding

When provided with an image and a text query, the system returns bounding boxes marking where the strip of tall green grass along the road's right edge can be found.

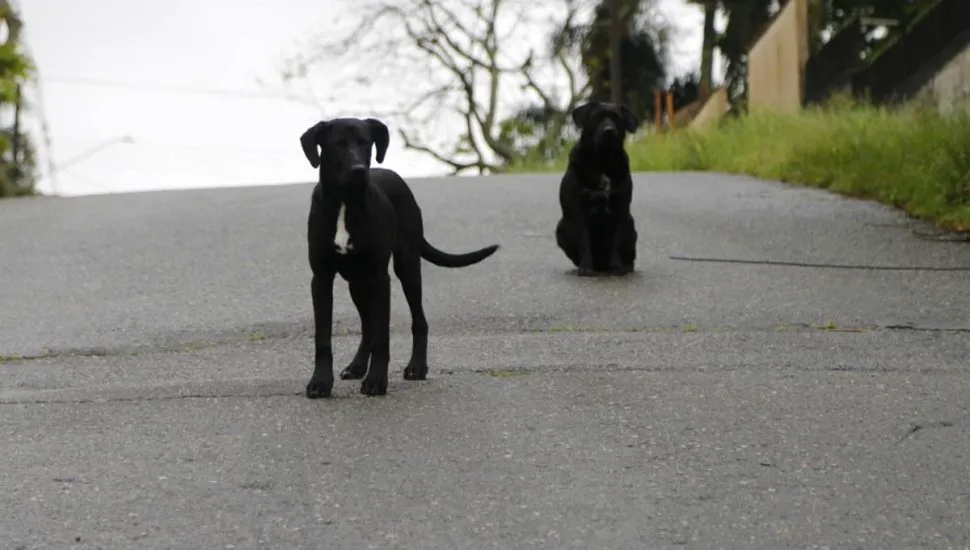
[515,98,970,230]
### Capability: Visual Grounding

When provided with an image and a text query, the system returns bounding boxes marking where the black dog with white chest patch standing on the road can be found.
[300,118,498,398]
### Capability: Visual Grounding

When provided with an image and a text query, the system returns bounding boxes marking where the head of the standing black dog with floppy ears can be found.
[300,118,390,190]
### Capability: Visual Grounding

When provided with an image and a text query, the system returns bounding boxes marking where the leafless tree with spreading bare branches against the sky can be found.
[272,0,589,174]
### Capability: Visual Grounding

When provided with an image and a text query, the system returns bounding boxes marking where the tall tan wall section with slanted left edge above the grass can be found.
[748,0,808,112]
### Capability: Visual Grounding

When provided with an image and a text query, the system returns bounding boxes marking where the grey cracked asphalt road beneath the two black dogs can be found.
[0,174,970,550]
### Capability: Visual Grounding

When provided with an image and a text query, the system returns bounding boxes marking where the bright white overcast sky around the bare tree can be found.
[20,0,702,195]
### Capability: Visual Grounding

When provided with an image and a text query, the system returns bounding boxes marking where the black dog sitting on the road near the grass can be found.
[556,101,639,276]
